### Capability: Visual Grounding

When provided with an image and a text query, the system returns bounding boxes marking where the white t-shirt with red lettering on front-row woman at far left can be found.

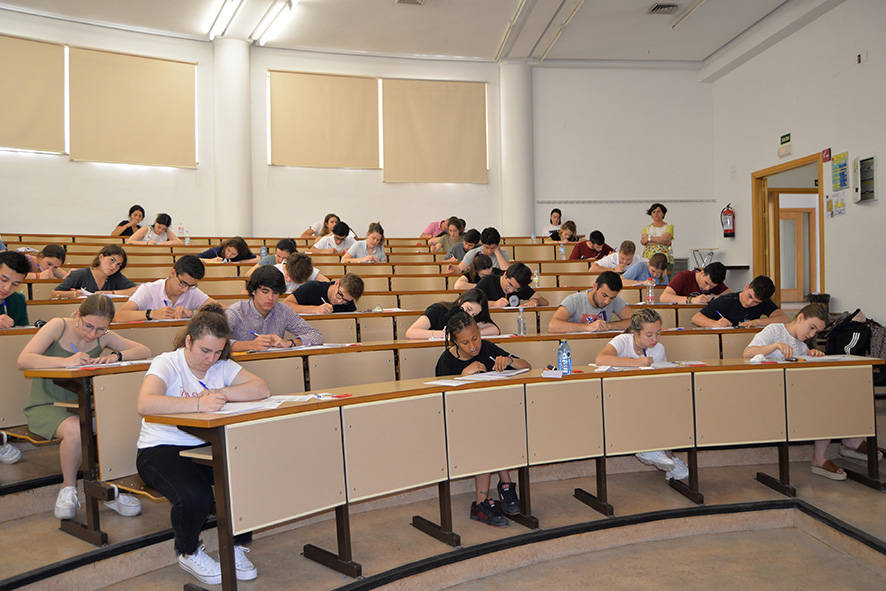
[136,349,241,449]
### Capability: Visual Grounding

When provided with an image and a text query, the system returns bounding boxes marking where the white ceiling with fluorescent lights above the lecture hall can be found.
[0,0,788,63]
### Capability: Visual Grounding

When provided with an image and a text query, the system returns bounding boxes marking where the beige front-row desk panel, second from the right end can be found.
[695,369,787,447]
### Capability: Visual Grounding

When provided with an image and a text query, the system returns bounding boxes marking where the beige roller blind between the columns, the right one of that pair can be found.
[382,79,487,183]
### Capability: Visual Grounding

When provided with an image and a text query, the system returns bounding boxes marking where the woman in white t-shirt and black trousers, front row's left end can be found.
[136,306,270,585]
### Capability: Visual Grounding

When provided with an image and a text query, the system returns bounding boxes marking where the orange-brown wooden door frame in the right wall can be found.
[751,152,825,302]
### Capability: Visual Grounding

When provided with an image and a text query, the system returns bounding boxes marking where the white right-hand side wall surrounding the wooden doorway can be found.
[713,0,886,321]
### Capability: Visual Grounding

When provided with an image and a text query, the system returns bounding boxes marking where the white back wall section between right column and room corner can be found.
[533,66,720,264]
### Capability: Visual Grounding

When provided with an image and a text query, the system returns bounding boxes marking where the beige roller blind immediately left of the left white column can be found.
[70,47,197,168]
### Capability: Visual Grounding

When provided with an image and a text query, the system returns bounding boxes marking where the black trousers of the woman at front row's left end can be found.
[136,445,252,555]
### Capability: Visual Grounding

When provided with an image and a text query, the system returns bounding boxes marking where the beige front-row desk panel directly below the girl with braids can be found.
[445,384,527,478]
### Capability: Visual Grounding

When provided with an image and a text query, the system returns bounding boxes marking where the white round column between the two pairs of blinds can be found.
[212,38,253,236]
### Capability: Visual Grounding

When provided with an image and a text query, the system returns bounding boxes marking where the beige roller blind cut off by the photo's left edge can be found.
[0,35,65,152]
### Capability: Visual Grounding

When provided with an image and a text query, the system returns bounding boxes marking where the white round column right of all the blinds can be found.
[499,61,535,236]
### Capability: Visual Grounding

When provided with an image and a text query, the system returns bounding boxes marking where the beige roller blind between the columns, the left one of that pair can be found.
[270,71,378,168]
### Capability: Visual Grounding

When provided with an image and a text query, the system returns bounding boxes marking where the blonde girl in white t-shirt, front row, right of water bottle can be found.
[594,310,689,480]
